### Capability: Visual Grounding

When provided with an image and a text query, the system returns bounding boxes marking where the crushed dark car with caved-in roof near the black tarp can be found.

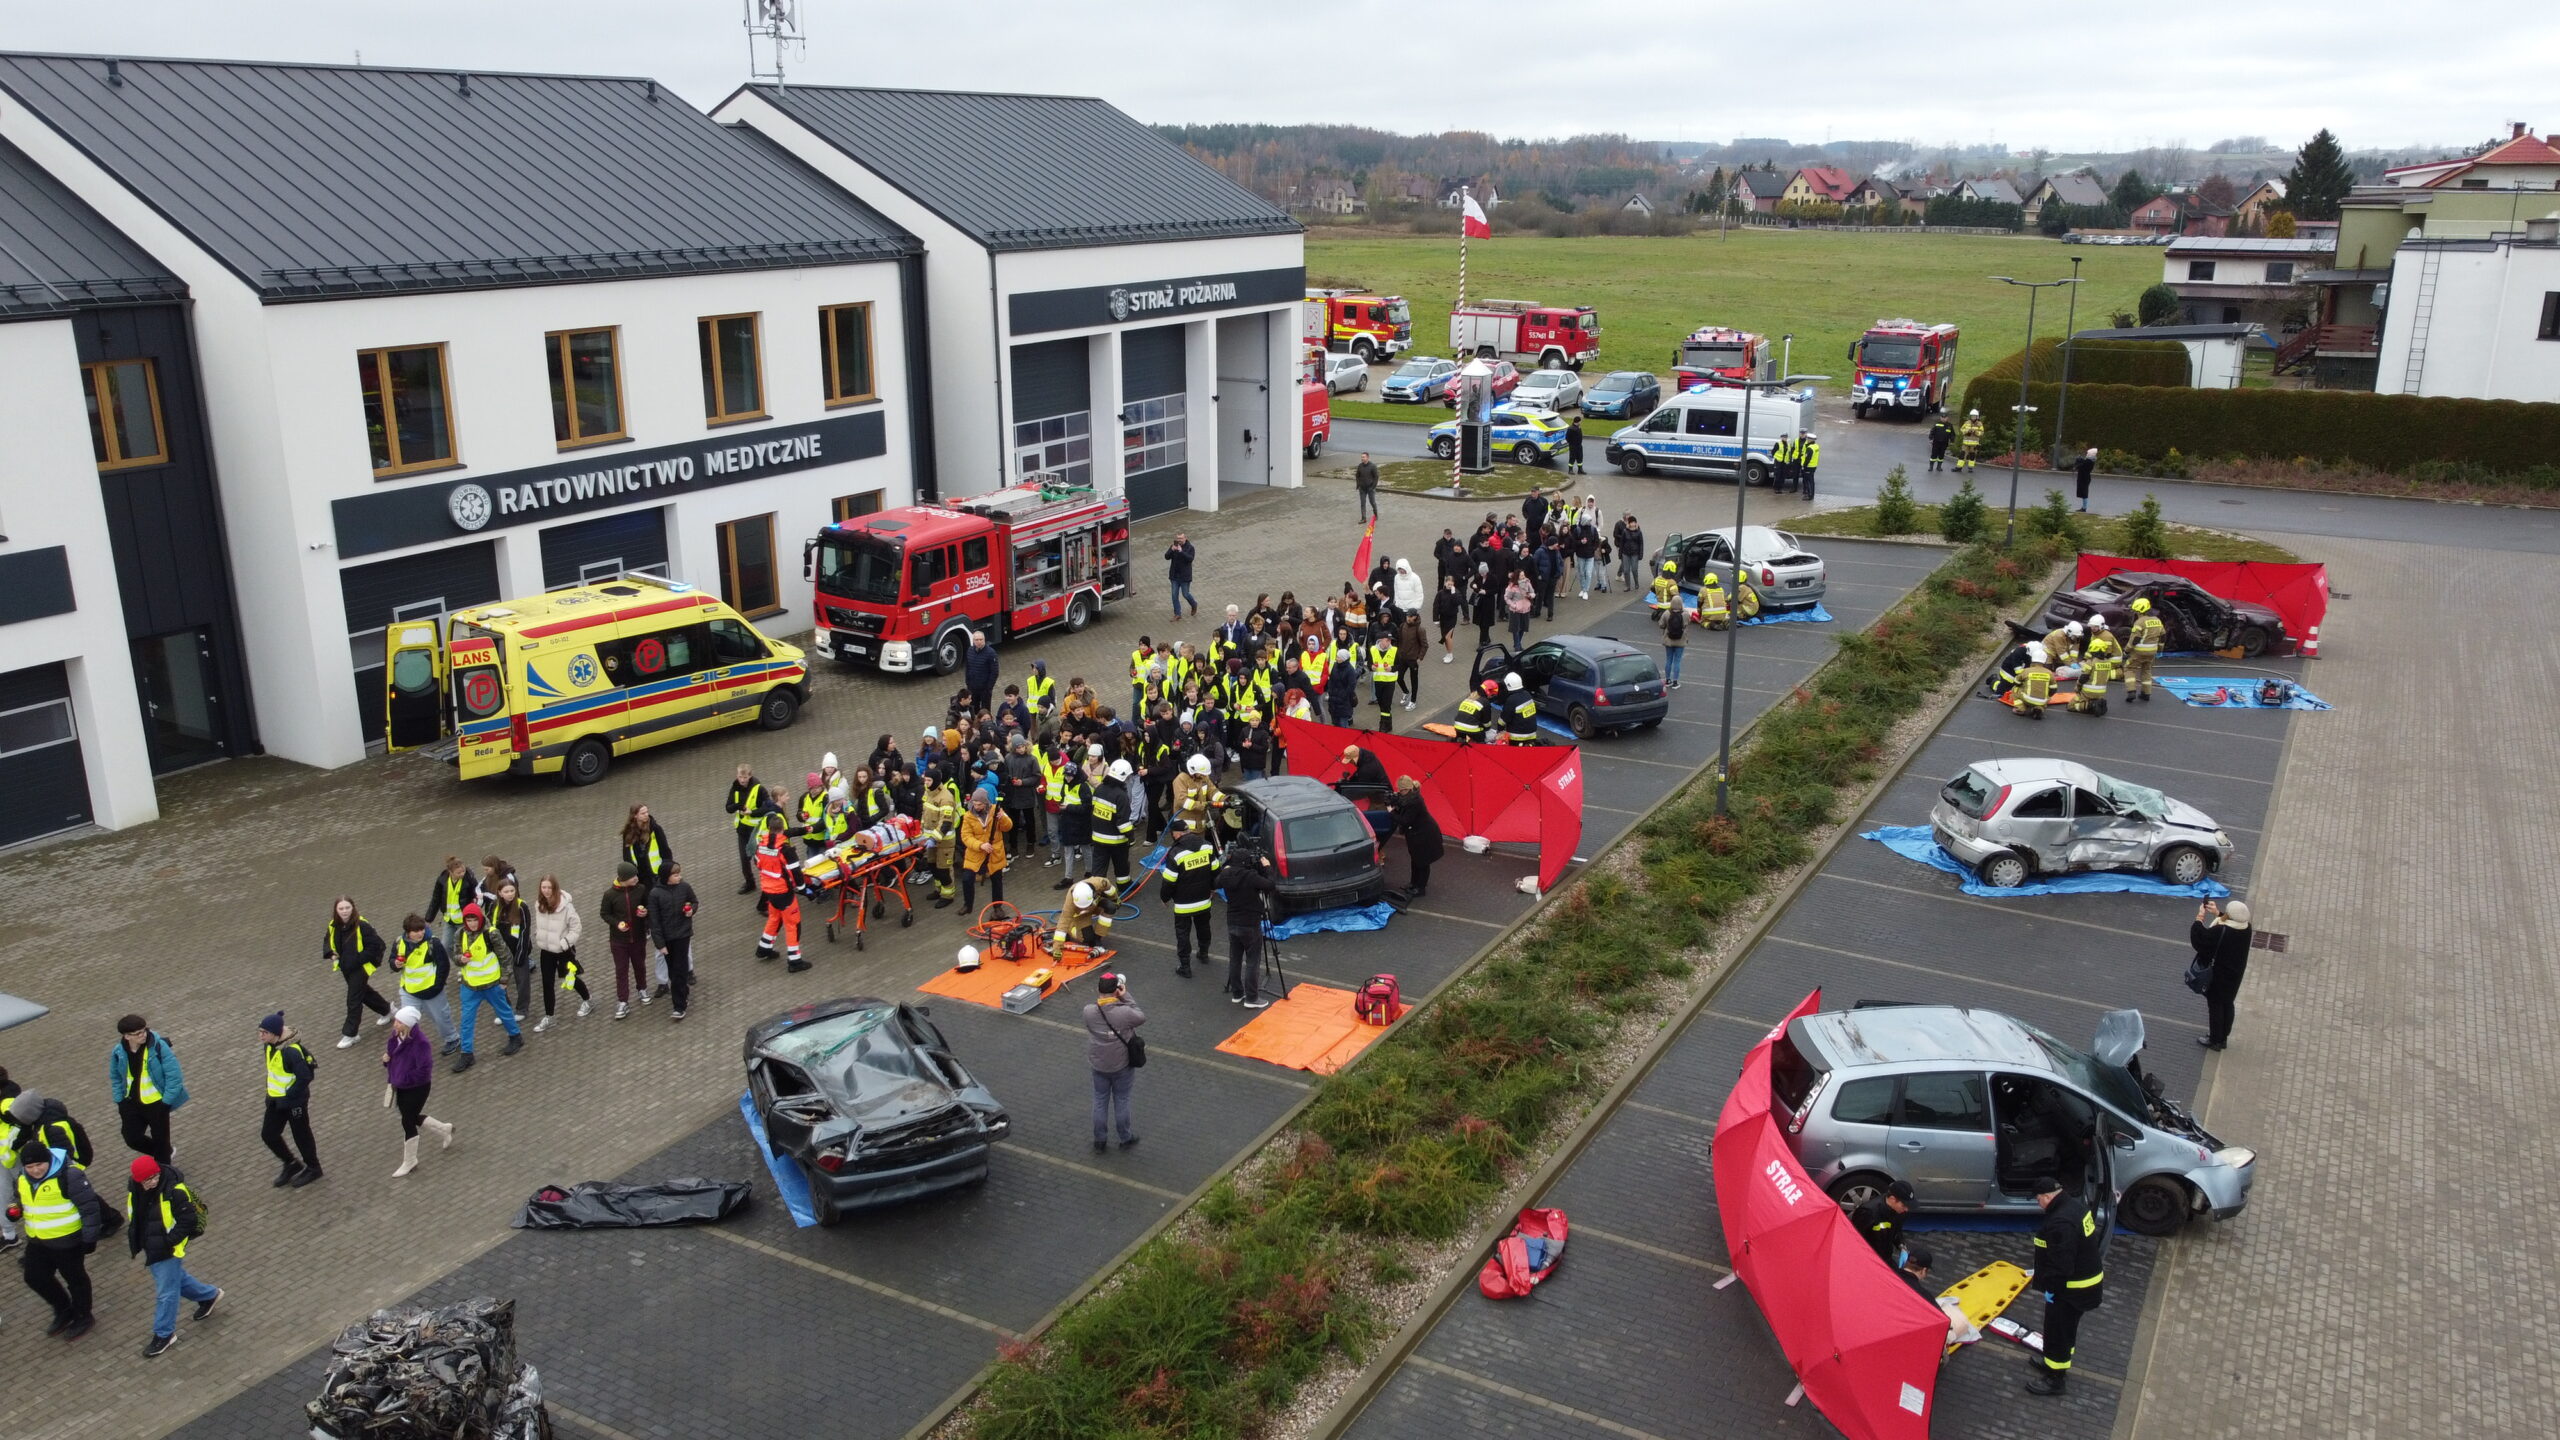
[748,997,1011,1225]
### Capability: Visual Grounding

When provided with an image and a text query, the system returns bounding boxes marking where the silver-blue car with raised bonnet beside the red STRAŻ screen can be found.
[1769,1004,2258,1235]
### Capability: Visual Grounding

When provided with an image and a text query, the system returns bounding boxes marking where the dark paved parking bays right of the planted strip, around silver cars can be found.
[1349,620,2322,1440]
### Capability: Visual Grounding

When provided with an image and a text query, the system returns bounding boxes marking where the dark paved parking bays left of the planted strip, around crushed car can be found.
[165,543,1938,1440]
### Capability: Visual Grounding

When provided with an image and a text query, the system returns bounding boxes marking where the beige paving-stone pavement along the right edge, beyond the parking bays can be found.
[2120,541,2560,1440]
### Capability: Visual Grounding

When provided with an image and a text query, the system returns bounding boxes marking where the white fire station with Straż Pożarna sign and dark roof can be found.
[714,85,1306,515]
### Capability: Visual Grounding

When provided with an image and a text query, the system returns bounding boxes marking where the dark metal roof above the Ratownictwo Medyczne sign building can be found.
[0,54,916,300]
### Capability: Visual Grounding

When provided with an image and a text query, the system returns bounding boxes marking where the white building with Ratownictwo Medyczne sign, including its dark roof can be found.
[0,54,929,766]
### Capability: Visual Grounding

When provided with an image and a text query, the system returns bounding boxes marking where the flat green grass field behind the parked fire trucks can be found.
[1306,228,2161,397]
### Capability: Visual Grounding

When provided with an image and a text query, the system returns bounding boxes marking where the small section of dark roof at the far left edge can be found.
[0,128,187,320]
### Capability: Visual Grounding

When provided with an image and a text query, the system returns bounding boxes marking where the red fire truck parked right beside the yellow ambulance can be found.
[801,482,1129,674]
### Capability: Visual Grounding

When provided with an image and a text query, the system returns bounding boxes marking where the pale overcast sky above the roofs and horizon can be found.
[0,0,2560,151]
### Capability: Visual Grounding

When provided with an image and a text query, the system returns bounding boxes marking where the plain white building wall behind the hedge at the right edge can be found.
[2373,217,2560,402]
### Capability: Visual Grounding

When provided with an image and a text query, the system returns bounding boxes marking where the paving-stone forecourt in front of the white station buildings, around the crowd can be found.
[0,474,1822,1440]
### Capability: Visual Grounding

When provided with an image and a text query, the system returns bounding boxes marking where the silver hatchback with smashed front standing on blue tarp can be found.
[1928,758,2232,889]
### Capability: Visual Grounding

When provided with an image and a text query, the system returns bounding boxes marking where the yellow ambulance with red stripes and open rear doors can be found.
[384,574,809,784]
